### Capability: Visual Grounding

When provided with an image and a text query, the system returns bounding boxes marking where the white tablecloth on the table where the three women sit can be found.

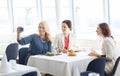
[28,52,96,76]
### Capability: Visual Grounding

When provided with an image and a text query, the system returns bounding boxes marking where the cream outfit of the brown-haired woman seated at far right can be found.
[101,37,116,73]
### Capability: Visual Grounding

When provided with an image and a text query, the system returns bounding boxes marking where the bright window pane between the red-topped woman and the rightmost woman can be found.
[74,0,105,38]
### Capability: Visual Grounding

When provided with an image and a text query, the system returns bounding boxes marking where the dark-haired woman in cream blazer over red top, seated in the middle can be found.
[53,20,77,53]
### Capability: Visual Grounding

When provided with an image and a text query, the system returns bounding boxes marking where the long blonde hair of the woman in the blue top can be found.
[38,21,52,43]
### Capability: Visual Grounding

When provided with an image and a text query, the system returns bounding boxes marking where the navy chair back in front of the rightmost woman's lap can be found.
[87,57,106,76]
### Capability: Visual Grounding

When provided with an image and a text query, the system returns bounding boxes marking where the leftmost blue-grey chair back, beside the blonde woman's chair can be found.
[5,43,18,61]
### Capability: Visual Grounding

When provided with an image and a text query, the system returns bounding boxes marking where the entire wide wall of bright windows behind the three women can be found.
[0,0,120,38]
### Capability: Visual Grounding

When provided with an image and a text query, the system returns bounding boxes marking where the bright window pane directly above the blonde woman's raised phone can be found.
[13,0,38,32]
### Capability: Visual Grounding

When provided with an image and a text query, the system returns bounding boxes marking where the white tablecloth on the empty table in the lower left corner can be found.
[0,64,41,76]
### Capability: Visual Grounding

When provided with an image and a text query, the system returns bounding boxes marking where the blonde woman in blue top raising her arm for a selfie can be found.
[17,21,51,55]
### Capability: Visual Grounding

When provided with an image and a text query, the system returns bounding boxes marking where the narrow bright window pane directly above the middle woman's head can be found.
[56,0,74,32]
